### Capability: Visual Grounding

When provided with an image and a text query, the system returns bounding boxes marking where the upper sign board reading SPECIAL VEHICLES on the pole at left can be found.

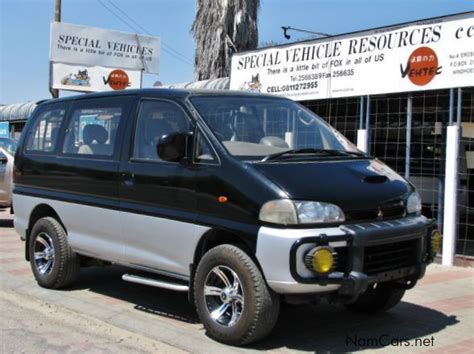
[49,22,160,74]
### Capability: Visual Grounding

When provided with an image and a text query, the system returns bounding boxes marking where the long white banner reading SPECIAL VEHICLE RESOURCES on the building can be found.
[230,12,474,100]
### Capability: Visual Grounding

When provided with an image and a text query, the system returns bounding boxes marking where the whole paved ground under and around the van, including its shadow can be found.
[0,212,474,353]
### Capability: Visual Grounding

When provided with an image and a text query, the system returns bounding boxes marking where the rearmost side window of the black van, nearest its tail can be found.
[26,105,67,153]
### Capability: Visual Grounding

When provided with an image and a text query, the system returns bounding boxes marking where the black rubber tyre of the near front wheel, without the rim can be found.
[194,244,280,346]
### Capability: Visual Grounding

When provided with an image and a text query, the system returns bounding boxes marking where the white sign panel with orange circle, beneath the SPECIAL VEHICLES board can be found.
[51,63,142,92]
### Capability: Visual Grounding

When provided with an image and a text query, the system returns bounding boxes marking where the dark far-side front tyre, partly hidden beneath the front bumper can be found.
[346,284,405,314]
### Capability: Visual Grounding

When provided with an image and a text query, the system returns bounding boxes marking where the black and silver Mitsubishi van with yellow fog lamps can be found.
[13,89,440,345]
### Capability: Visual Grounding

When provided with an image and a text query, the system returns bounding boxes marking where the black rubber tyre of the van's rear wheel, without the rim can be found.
[28,217,80,289]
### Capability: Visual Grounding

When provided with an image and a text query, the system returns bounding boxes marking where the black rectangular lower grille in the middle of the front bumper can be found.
[364,240,418,275]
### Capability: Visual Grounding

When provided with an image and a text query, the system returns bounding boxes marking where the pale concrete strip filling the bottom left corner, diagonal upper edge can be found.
[0,290,184,354]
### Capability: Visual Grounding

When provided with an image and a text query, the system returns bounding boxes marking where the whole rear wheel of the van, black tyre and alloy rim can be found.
[28,217,80,289]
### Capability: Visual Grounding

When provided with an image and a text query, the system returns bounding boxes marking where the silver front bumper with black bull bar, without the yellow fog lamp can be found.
[257,216,435,296]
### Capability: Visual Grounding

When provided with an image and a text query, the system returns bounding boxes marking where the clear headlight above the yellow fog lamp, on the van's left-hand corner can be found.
[259,199,346,225]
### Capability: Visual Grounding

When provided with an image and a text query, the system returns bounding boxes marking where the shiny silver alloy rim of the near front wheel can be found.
[204,265,245,327]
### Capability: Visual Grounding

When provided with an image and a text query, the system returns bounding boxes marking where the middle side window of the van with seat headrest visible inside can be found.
[62,99,128,157]
